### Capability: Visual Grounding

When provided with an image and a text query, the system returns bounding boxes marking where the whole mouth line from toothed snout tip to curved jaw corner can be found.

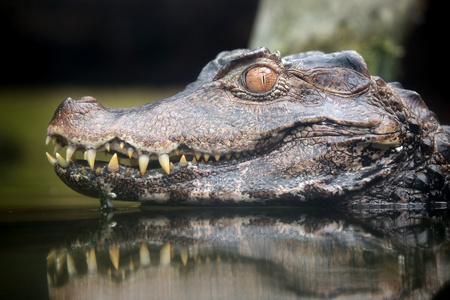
[45,122,392,177]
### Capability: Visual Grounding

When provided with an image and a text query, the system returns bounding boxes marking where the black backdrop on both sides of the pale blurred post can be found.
[0,0,450,123]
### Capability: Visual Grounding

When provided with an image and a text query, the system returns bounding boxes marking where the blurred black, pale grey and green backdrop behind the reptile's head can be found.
[0,0,450,211]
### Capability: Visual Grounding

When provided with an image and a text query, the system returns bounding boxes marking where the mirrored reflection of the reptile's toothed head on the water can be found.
[47,208,450,299]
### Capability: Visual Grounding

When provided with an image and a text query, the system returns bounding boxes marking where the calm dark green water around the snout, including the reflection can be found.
[0,87,450,299]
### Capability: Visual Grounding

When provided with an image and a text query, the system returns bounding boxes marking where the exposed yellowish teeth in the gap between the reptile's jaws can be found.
[46,135,270,177]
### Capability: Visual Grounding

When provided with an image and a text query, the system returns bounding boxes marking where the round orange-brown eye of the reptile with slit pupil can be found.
[245,66,278,93]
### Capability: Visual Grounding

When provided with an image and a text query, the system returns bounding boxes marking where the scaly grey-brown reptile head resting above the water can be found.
[47,48,450,204]
